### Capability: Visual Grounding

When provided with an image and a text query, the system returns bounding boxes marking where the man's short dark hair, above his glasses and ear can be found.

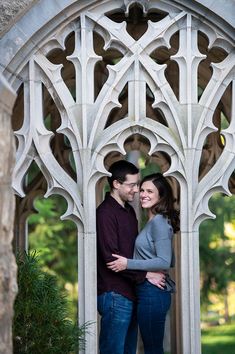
[108,160,139,189]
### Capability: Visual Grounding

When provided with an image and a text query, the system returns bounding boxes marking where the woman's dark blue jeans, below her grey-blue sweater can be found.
[136,280,171,354]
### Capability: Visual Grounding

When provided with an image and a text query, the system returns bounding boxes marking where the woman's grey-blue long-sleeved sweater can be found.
[127,218,172,271]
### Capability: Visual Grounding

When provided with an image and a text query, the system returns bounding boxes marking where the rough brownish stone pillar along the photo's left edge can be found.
[0,75,17,354]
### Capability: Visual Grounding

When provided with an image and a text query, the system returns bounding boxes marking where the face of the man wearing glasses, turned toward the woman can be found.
[117,173,139,202]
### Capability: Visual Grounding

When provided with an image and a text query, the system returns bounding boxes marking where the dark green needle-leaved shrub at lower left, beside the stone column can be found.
[13,252,87,354]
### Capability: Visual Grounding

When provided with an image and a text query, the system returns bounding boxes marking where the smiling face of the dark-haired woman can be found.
[140,181,160,209]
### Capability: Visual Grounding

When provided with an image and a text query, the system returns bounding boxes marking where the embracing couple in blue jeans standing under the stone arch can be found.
[97,160,179,354]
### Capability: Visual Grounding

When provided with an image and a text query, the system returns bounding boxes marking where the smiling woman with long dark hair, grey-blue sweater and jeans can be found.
[107,173,179,354]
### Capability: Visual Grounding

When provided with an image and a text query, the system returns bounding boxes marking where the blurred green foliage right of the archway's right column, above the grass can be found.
[200,194,235,305]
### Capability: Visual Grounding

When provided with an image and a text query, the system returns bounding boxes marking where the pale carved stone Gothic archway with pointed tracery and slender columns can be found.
[0,0,235,354]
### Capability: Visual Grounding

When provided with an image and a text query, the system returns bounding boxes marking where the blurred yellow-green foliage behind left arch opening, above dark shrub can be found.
[28,195,78,319]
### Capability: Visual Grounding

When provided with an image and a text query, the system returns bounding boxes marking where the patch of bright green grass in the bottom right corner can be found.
[202,322,235,354]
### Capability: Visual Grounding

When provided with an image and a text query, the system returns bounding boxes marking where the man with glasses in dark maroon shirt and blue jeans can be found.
[96,160,164,354]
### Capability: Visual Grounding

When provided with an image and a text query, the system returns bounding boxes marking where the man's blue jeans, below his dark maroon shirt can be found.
[98,291,138,354]
